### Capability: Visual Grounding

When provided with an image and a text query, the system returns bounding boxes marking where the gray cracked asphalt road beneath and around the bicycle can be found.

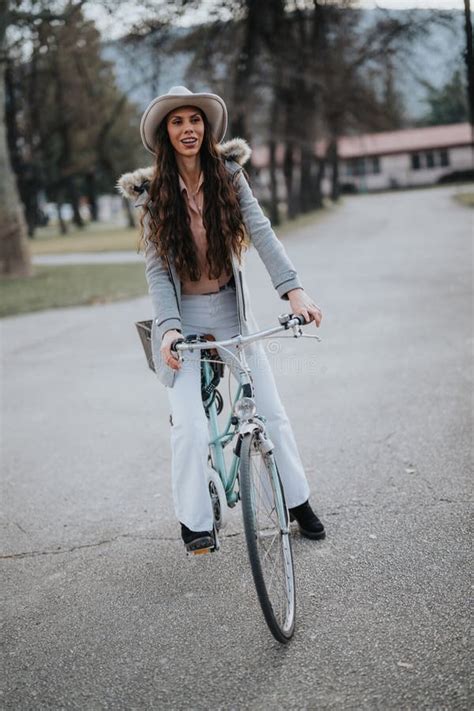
[0,188,473,711]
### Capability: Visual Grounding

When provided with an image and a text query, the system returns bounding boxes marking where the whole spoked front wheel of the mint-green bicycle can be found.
[239,431,296,643]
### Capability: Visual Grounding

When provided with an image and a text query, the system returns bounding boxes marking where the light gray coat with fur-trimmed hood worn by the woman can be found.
[119,139,302,387]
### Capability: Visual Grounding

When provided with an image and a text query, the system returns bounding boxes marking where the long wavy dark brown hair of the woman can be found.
[141,111,249,281]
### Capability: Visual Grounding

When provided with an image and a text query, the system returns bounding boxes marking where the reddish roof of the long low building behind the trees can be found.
[252,123,472,168]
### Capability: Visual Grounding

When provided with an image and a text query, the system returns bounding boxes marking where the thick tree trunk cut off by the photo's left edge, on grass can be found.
[0,23,32,277]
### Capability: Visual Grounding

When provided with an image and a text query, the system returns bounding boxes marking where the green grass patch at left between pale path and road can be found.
[0,262,148,317]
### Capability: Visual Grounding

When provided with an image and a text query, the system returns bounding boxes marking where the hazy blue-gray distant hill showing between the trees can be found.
[103,10,465,122]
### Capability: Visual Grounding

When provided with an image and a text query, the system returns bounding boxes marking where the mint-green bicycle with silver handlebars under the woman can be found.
[171,314,321,643]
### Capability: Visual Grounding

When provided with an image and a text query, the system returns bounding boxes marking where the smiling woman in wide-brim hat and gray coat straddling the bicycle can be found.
[119,86,325,549]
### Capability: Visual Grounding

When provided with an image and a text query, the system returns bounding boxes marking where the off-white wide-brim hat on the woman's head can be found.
[140,86,227,153]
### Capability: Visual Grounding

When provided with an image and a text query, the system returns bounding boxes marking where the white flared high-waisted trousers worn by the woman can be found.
[166,287,309,531]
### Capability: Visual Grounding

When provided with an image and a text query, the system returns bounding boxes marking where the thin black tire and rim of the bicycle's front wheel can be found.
[239,431,296,644]
